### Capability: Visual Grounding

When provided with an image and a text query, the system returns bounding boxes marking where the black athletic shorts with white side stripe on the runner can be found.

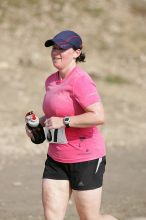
[43,156,106,190]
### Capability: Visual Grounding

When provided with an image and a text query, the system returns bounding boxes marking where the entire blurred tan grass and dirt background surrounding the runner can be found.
[0,0,146,220]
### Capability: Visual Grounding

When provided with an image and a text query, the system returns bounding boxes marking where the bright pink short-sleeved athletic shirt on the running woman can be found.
[43,67,105,163]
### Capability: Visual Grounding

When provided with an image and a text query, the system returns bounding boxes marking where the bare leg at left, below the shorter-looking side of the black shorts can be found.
[42,179,71,220]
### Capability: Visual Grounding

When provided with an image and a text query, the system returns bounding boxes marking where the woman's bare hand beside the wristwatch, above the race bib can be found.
[44,117,65,129]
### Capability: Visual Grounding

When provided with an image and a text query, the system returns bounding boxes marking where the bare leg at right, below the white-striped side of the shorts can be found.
[73,187,117,220]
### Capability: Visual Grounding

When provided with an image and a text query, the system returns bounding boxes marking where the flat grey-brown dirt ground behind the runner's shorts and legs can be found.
[0,144,146,220]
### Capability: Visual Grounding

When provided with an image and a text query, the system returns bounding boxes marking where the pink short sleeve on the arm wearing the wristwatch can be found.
[73,74,101,108]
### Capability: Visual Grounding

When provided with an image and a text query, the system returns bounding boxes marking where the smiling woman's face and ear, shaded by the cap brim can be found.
[51,45,81,70]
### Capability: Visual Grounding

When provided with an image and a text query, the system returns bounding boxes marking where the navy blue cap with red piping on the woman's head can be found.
[45,30,82,50]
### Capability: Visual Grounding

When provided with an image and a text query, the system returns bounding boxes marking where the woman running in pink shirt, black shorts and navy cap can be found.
[26,30,116,220]
